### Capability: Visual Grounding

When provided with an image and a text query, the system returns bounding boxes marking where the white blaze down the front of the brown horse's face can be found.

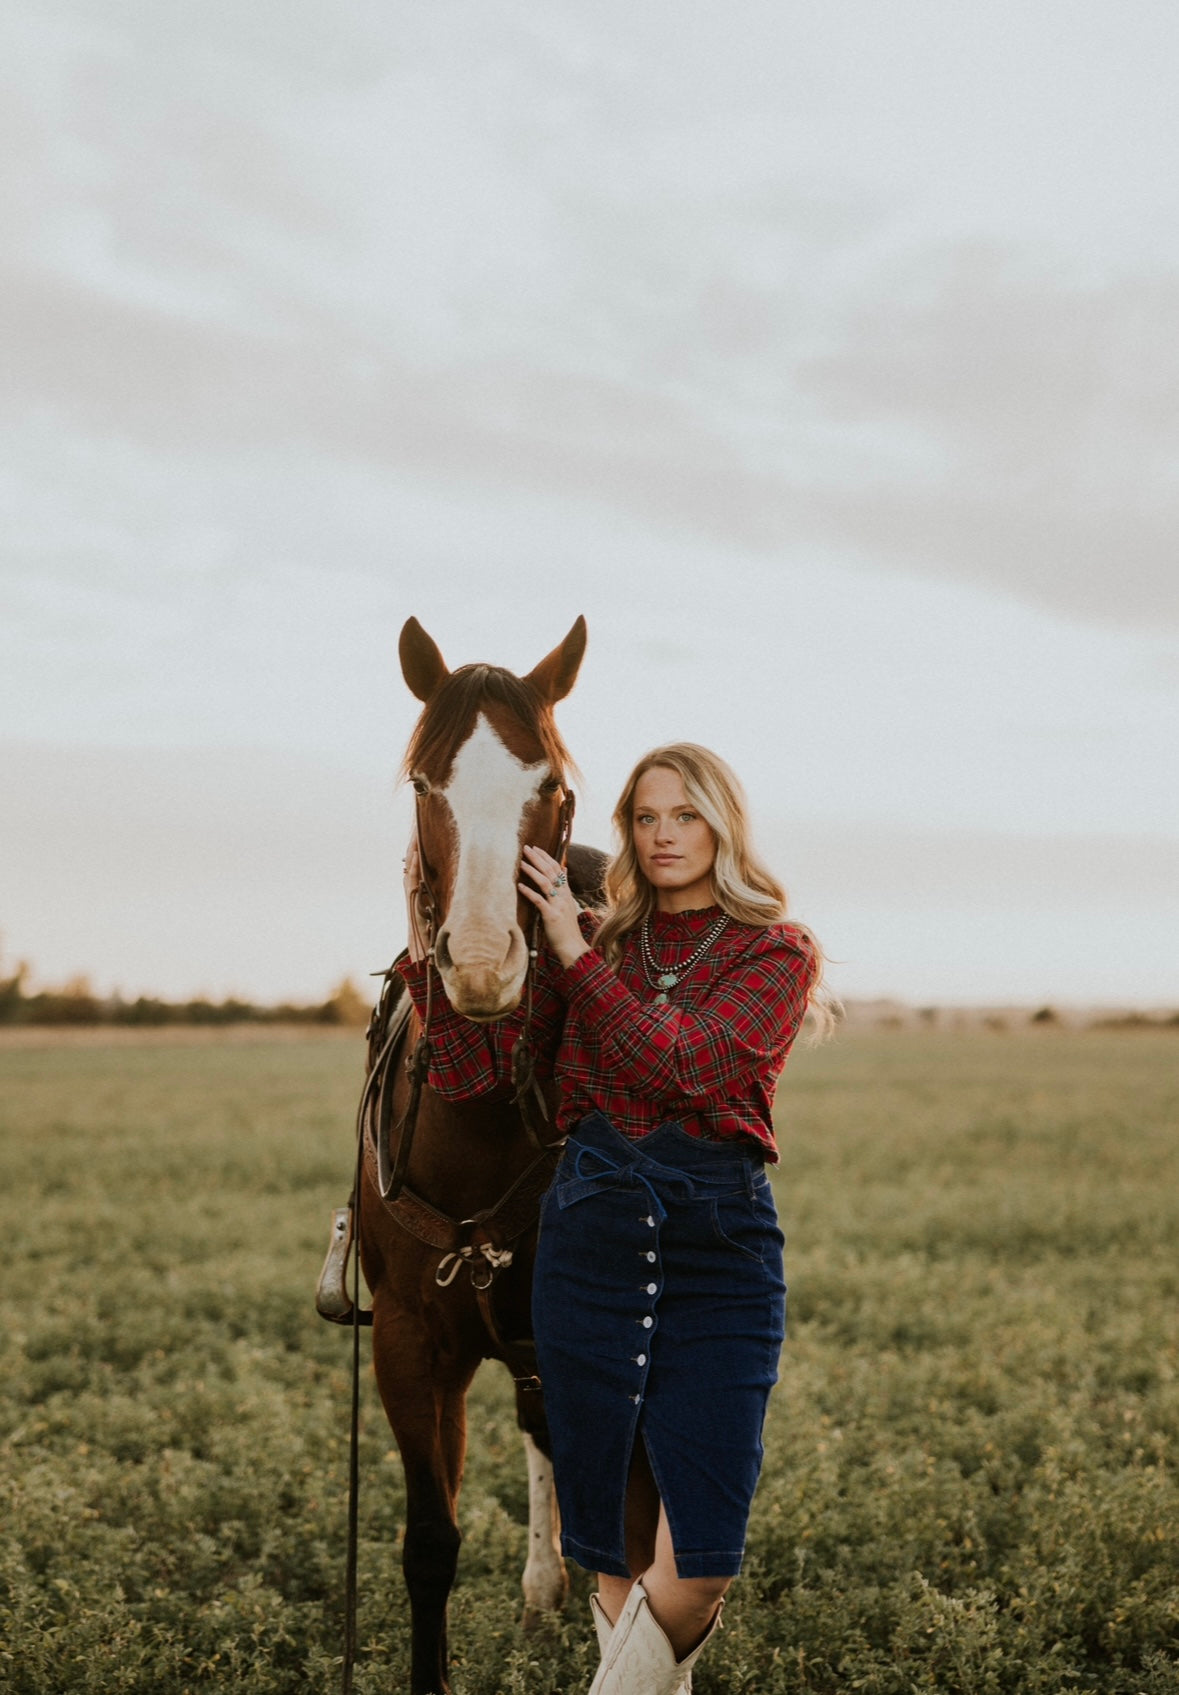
[439,714,549,1017]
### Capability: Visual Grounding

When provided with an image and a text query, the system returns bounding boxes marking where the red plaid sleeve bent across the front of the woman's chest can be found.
[564,931,815,1098]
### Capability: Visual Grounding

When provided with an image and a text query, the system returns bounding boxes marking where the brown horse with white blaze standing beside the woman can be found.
[357,619,601,1695]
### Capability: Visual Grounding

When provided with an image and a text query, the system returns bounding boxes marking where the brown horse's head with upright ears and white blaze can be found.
[400,617,586,1020]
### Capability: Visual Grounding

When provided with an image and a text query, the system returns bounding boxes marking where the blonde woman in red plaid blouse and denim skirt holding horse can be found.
[403,742,820,1695]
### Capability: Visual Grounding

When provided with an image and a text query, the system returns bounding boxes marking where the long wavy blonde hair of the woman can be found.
[595,742,840,1036]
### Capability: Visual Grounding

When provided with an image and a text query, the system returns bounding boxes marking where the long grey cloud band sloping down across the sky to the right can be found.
[3,222,1179,644]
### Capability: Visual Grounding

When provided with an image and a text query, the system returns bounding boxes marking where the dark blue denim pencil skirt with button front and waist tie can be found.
[532,1112,786,1578]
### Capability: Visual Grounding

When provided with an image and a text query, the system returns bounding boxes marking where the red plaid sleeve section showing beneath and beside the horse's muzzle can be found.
[398,914,598,1100]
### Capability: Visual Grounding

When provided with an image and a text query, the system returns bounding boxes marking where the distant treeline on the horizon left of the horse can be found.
[0,964,369,1025]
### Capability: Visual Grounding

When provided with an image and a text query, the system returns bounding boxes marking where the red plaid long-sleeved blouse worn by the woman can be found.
[398,907,815,1163]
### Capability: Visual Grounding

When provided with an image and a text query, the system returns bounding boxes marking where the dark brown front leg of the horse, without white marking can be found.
[373,1332,478,1695]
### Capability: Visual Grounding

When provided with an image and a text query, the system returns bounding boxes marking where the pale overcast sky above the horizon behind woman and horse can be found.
[0,0,1179,1005]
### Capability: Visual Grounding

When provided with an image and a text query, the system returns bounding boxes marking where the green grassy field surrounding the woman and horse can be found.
[0,1031,1179,1695]
